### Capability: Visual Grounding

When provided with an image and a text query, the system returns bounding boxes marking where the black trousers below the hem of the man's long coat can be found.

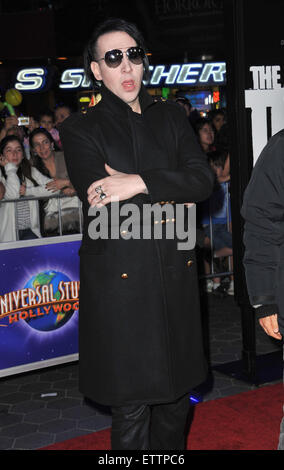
[111,393,190,450]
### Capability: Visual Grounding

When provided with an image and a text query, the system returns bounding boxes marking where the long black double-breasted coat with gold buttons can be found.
[60,82,214,406]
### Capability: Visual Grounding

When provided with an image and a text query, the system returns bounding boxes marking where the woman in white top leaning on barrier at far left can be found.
[0,135,58,242]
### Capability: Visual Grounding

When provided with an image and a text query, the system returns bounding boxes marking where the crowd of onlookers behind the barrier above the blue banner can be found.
[0,105,80,242]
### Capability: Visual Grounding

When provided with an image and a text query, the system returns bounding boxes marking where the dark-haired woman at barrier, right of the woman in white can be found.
[29,128,79,233]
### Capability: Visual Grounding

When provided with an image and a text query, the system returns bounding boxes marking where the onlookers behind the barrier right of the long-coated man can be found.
[176,96,234,296]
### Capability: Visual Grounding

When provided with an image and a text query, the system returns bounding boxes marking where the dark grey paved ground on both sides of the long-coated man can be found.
[0,295,281,450]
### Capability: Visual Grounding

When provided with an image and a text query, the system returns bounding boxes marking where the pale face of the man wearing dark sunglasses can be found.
[91,31,143,112]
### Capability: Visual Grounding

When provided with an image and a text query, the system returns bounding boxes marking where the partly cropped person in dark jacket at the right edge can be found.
[242,130,284,450]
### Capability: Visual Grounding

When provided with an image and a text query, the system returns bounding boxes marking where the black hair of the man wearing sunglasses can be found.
[84,18,149,86]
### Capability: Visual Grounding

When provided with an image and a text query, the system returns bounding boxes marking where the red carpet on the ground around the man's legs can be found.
[41,384,284,450]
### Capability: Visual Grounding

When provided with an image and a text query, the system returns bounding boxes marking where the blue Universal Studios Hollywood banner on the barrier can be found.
[0,241,81,375]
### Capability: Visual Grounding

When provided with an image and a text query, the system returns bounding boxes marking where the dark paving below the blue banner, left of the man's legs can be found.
[0,363,111,449]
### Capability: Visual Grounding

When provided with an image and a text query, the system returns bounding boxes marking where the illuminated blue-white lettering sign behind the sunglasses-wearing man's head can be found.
[15,62,226,91]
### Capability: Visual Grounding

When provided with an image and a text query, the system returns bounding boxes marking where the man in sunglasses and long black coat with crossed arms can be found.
[60,19,214,450]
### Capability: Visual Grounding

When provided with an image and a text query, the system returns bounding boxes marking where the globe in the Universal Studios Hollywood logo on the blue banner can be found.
[25,270,78,332]
